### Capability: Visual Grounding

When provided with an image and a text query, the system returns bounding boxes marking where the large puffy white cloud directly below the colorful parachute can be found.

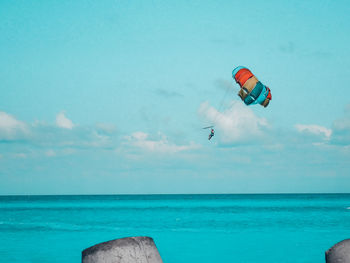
[198,101,269,144]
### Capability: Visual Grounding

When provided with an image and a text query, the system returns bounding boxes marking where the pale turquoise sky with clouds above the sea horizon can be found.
[0,0,350,195]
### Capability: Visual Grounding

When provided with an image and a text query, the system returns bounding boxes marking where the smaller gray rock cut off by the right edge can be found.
[326,239,350,263]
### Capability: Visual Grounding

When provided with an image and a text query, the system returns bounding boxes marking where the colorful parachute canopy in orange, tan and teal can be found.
[232,66,272,107]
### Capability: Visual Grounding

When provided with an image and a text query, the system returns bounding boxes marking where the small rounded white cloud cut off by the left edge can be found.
[0,112,29,140]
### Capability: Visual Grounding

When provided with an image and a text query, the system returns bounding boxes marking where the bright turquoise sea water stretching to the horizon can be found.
[0,194,350,263]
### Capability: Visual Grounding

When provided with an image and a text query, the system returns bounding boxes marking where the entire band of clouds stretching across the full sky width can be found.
[0,101,350,162]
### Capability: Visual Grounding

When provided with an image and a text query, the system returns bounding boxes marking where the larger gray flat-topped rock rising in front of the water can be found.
[82,237,163,263]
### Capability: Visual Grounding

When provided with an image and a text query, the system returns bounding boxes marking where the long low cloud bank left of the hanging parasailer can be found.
[0,112,199,158]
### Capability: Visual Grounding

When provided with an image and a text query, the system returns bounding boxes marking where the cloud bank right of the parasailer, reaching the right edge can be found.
[198,101,350,150]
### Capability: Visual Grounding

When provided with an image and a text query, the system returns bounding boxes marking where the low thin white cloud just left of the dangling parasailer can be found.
[125,132,199,153]
